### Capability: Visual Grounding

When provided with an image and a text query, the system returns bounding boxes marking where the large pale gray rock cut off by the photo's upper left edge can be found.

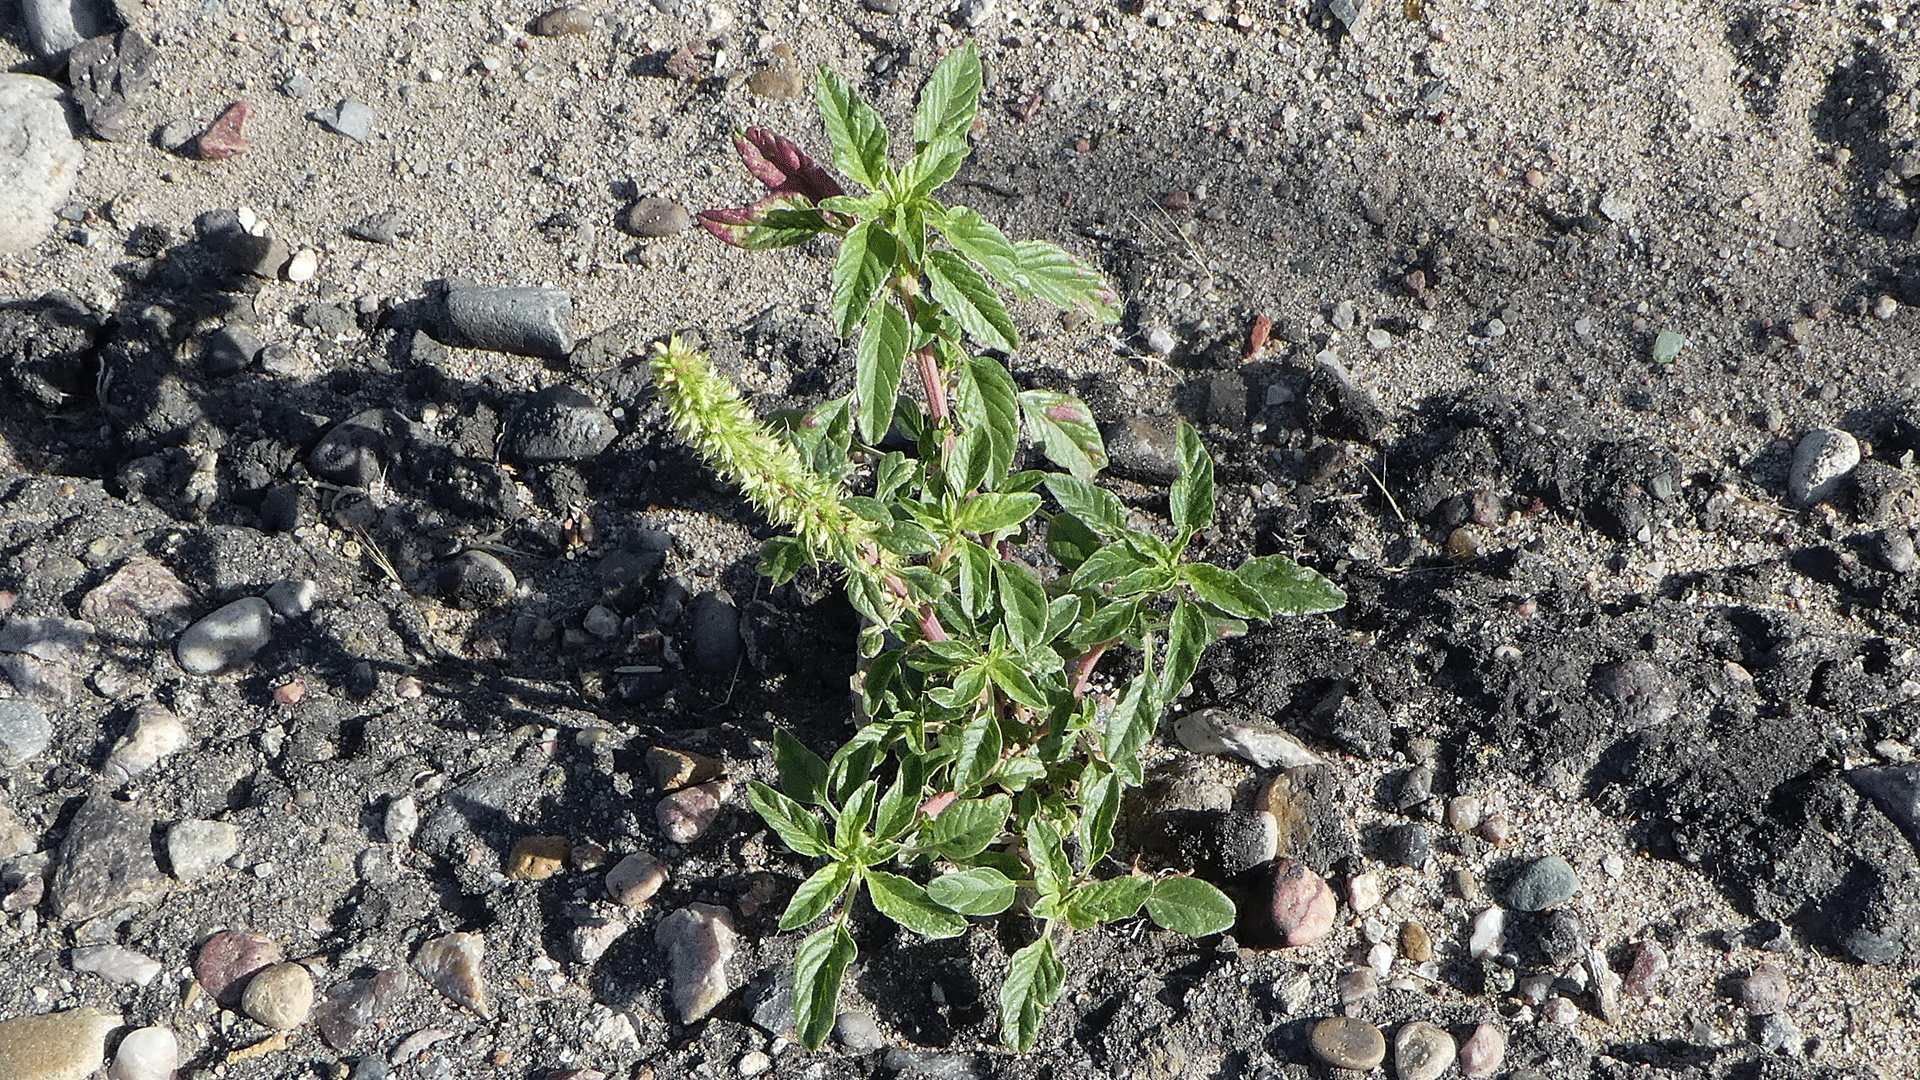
[0,75,86,256]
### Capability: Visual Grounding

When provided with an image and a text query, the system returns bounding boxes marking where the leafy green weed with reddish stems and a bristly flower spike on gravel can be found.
[651,48,1346,1049]
